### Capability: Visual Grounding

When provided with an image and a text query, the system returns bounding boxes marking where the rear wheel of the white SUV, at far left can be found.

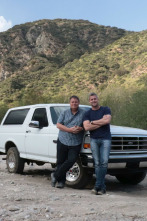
[6,147,25,173]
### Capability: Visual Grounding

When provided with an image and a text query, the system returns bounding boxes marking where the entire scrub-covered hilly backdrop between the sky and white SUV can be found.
[0,19,147,129]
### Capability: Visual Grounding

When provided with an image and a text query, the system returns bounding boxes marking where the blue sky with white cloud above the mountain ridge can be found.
[0,0,147,32]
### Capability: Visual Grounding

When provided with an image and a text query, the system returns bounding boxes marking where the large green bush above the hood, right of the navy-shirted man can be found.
[101,86,147,129]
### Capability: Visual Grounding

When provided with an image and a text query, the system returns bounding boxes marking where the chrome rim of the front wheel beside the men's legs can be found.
[66,163,80,182]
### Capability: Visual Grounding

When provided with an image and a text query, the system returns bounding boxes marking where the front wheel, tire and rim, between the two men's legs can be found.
[66,160,93,189]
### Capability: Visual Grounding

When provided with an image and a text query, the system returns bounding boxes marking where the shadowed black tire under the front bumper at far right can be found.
[116,172,146,185]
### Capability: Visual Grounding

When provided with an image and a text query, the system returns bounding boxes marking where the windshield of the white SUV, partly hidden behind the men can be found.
[50,106,90,124]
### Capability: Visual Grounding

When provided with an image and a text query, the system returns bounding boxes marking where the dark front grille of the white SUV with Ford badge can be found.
[111,136,147,151]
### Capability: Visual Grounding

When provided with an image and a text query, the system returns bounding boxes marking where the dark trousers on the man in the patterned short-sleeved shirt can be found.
[54,139,81,182]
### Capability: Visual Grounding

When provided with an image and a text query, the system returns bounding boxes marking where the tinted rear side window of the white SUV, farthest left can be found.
[3,108,29,125]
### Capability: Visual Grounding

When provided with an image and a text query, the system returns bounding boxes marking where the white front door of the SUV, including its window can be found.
[25,108,50,162]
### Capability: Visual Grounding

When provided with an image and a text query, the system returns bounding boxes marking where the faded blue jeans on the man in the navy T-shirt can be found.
[90,138,111,190]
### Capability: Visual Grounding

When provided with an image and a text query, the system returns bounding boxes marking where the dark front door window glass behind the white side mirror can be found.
[32,108,48,127]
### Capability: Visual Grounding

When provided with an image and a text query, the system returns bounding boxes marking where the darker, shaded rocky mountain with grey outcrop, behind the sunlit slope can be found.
[0,19,128,103]
